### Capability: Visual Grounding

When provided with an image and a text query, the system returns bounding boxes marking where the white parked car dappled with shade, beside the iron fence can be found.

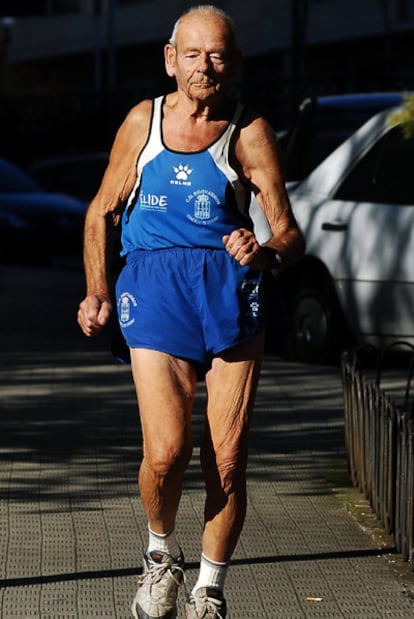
[273,105,414,362]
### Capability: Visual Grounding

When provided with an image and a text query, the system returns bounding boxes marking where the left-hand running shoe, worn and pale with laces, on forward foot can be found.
[132,551,184,619]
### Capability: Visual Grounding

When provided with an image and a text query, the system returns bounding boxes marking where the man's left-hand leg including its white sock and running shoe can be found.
[131,348,196,618]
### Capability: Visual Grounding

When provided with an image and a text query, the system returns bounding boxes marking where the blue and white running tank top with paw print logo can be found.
[121,97,251,255]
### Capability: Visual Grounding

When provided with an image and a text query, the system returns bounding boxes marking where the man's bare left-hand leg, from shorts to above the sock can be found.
[131,348,196,533]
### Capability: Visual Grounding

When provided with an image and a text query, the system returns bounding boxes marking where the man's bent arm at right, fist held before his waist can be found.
[223,115,305,269]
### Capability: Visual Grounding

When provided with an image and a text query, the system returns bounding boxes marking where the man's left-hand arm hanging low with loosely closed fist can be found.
[78,101,152,336]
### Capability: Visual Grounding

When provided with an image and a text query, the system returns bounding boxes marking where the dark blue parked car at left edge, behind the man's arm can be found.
[0,159,86,265]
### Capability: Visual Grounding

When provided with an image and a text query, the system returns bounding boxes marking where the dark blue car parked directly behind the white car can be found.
[283,92,403,186]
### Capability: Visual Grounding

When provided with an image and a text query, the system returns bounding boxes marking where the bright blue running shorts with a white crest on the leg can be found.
[116,248,264,362]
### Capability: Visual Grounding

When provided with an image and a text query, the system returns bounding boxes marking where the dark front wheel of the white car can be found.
[286,286,337,363]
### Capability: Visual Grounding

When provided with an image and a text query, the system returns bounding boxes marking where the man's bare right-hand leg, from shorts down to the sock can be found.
[201,335,263,562]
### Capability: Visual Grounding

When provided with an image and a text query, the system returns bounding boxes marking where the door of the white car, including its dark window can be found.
[318,127,414,343]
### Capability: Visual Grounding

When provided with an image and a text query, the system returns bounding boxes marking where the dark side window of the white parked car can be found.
[334,127,414,204]
